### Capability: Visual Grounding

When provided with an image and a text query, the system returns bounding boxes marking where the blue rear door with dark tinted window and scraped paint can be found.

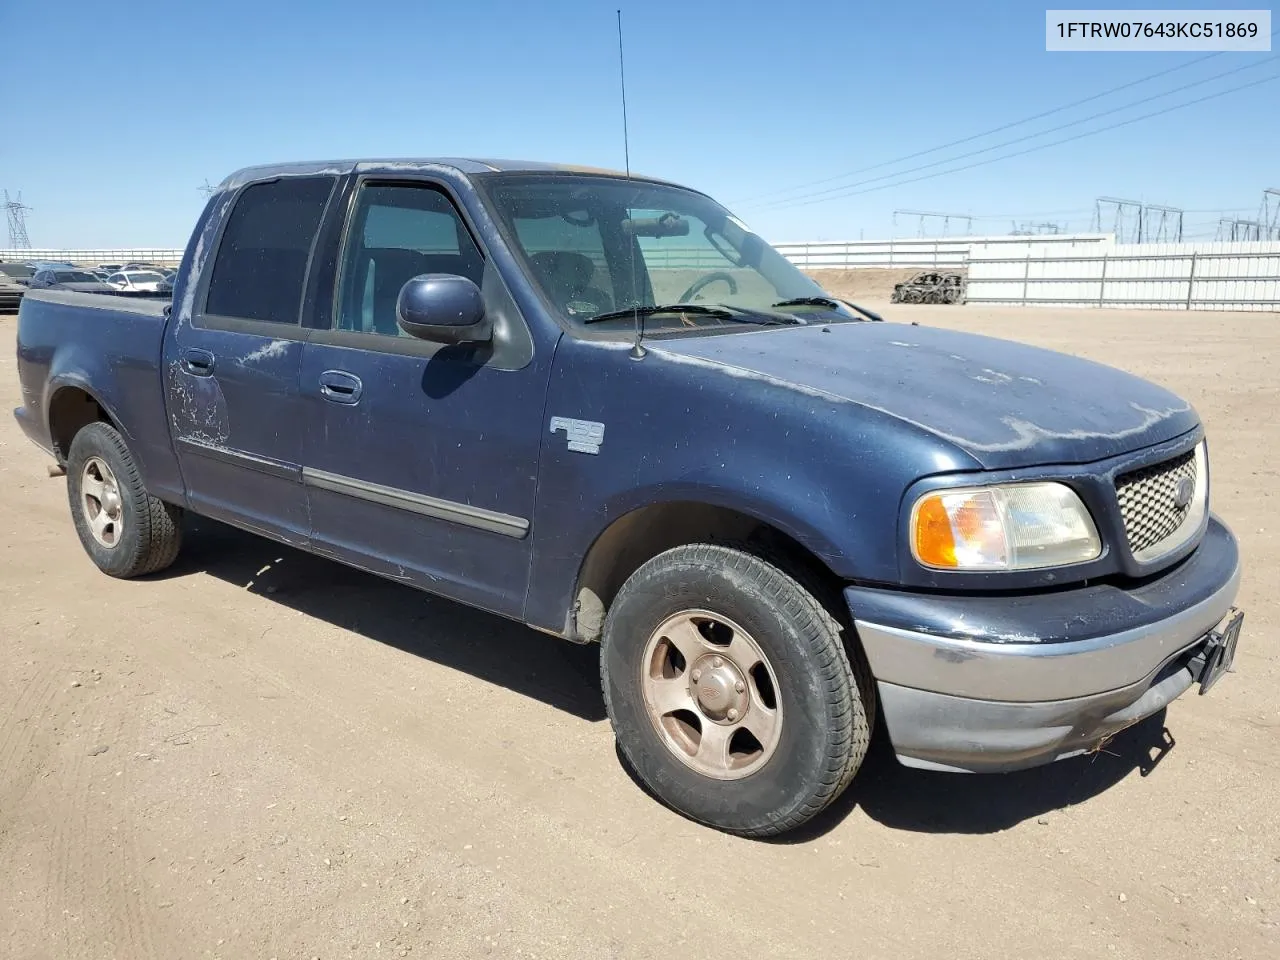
[164,177,335,543]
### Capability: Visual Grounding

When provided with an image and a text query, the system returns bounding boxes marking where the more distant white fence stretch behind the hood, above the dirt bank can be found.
[773,233,1112,270]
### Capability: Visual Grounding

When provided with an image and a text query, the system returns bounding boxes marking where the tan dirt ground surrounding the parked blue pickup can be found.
[0,305,1280,960]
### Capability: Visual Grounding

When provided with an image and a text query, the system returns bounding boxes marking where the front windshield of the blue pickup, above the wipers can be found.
[488,174,844,333]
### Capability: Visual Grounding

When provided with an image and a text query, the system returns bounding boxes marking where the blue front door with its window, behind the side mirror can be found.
[300,179,548,616]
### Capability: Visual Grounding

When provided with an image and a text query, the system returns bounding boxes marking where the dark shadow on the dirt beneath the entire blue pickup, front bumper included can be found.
[160,517,1174,844]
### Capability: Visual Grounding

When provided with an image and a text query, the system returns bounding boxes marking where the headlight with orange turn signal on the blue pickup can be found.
[911,483,1102,571]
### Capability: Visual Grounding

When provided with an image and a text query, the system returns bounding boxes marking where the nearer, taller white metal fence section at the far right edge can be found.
[966,241,1280,311]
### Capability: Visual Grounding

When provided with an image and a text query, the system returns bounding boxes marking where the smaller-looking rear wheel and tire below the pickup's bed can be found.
[67,421,182,579]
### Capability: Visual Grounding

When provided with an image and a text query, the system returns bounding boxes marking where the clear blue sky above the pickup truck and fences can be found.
[0,0,1280,247]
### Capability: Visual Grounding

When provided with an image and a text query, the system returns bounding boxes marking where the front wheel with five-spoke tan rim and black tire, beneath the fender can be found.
[600,544,874,837]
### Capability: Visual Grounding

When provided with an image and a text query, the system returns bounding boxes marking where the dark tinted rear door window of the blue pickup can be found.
[205,177,335,324]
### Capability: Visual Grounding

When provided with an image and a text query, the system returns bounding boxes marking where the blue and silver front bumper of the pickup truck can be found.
[845,517,1240,772]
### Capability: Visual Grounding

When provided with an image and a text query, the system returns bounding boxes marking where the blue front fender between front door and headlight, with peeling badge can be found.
[526,338,973,630]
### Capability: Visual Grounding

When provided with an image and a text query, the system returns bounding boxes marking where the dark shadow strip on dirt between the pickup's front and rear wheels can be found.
[161,516,605,722]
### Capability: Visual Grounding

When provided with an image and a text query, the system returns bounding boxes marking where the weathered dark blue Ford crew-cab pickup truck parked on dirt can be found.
[17,159,1242,836]
